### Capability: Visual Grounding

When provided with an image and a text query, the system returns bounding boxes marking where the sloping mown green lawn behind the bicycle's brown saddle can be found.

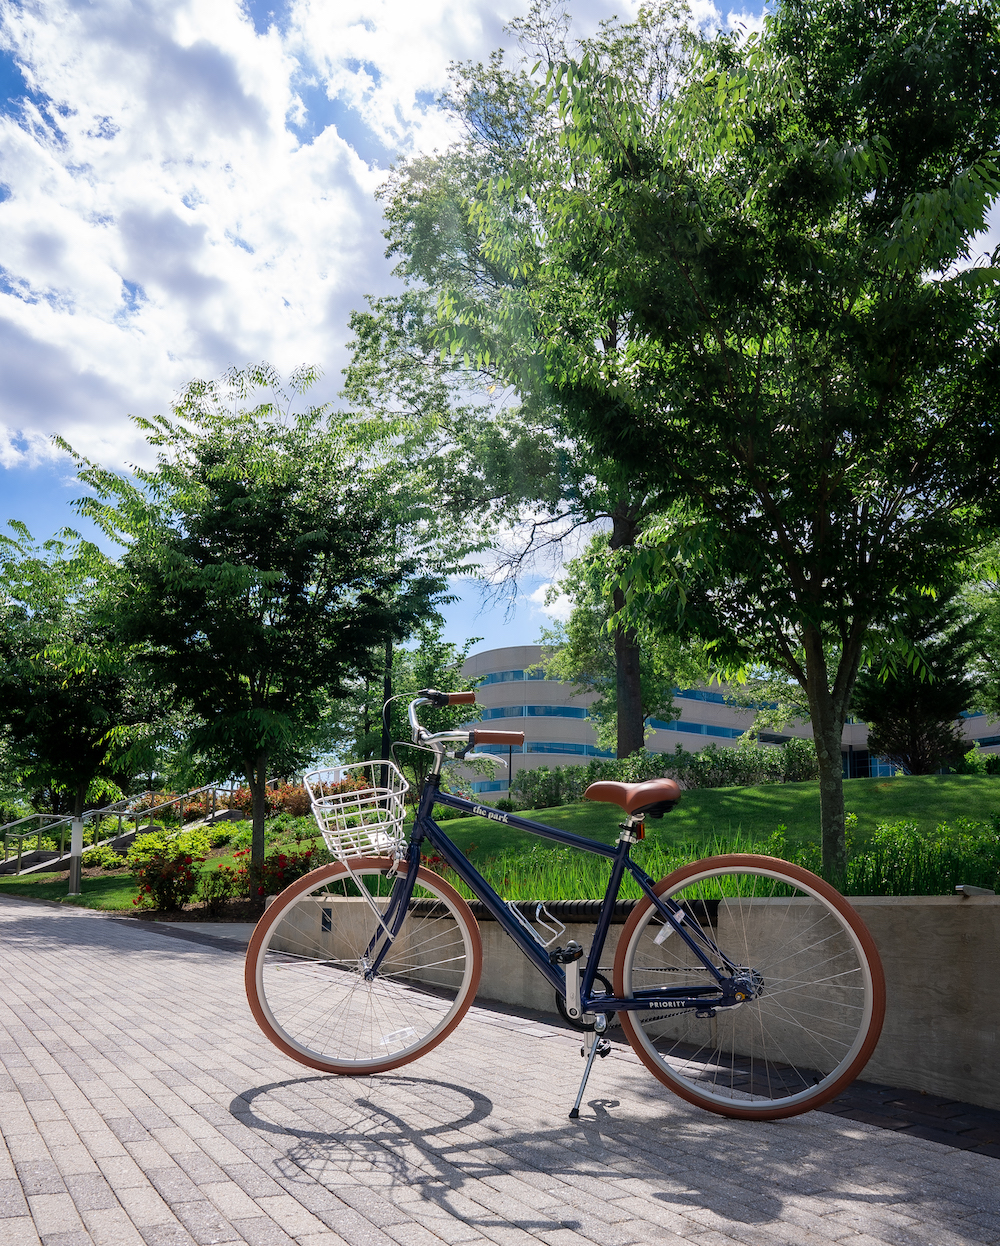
[442,775,1000,857]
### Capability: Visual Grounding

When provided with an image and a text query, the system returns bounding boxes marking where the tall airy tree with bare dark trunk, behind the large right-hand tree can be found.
[345,4,686,756]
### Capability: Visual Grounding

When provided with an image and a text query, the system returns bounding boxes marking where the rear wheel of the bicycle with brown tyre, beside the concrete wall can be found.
[614,854,885,1120]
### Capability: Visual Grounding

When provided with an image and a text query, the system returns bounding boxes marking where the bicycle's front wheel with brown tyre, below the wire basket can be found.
[245,857,483,1075]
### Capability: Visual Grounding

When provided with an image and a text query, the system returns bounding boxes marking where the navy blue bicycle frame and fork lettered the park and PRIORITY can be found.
[372,776,736,1012]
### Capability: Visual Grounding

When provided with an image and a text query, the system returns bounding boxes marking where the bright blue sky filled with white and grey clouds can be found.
[0,0,760,648]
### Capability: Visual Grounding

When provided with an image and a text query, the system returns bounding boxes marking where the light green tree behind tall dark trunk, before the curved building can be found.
[542,536,709,758]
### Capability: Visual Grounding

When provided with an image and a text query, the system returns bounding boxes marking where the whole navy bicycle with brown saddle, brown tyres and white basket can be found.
[245,688,885,1120]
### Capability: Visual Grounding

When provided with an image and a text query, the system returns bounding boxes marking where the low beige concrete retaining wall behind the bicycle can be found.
[479,896,1000,1109]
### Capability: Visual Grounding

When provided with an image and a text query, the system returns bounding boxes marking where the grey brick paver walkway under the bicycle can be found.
[0,896,1000,1246]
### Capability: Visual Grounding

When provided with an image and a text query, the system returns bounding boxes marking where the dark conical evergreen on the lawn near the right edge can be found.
[852,591,979,775]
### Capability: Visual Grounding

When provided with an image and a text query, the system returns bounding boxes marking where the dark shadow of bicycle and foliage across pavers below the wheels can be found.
[230,1074,1000,1240]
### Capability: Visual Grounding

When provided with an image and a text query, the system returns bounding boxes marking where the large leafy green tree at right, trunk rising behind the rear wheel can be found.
[438,0,1000,882]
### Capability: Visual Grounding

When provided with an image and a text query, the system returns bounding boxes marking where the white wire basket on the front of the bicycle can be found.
[305,761,410,861]
